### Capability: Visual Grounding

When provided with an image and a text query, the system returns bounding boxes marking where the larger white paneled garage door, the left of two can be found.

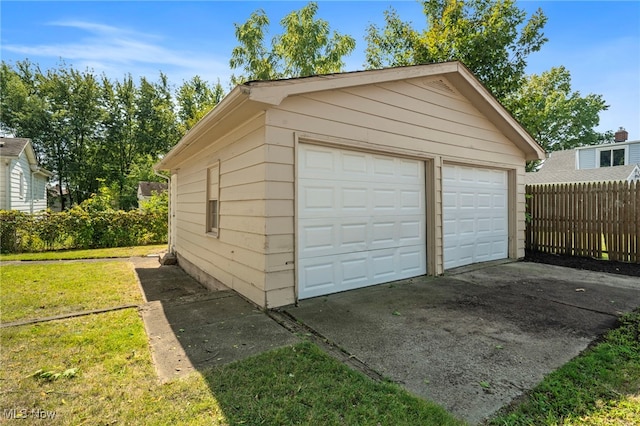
[296,144,426,299]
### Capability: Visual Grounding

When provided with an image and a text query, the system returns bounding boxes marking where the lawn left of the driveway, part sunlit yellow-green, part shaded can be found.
[0,261,462,425]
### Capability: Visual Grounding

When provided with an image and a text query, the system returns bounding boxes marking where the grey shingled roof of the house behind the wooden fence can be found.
[525,146,640,184]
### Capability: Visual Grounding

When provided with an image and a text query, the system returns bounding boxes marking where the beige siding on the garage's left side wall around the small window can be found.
[175,116,265,305]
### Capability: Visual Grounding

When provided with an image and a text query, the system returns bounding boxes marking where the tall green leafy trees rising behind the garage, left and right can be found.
[0,0,612,208]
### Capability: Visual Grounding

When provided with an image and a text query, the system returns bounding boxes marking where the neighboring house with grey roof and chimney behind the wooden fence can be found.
[526,129,640,184]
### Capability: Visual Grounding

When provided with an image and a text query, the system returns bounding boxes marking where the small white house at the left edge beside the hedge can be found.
[0,137,53,213]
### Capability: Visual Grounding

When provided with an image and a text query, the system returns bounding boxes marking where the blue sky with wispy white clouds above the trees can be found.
[0,0,640,140]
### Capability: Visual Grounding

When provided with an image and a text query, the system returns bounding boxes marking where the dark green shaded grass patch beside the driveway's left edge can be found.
[205,342,463,425]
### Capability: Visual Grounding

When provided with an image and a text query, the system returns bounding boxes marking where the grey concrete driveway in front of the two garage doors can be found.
[284,262,640,424]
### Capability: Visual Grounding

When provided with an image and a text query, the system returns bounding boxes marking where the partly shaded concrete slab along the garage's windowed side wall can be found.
[132,258,299,382]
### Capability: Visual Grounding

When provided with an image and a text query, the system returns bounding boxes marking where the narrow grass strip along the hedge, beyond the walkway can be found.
[0,244,167,262]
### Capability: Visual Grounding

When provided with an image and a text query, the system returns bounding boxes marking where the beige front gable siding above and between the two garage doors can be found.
[267,78,525,274]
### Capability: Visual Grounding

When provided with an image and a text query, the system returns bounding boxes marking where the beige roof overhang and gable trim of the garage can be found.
[154,61,544,170]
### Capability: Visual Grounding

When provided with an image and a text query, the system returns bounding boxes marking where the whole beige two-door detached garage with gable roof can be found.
[156,62,544,308]
